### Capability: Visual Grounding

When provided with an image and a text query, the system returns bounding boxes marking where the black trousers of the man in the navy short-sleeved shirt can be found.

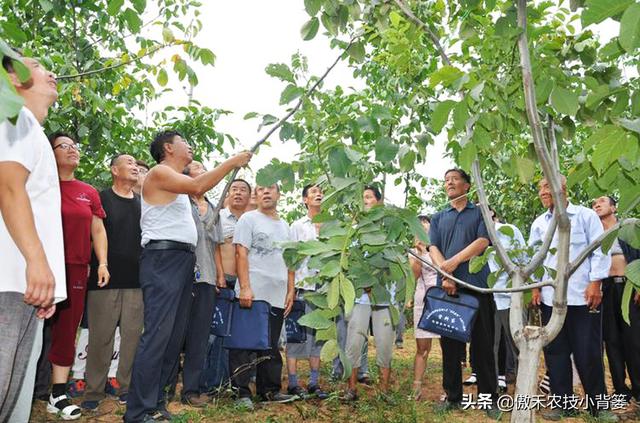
[440,290,498,402]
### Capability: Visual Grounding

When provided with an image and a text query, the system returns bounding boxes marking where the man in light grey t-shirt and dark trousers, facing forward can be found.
[229,184,296,408]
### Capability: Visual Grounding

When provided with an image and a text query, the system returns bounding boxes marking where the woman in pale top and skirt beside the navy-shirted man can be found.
[409,216,439,401]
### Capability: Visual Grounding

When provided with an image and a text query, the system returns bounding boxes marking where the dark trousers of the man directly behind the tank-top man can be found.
[182,283,216,398]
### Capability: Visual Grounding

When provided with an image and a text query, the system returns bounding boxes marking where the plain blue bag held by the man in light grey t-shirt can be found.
[222,300,271,351]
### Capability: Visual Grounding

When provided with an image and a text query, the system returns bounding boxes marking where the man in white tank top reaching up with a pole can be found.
[124,131,251,422]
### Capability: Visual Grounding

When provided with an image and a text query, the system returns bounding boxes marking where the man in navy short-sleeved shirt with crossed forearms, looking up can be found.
[429,169,500,418]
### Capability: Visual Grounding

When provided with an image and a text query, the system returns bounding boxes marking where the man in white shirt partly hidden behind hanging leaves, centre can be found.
[287,185,327,399]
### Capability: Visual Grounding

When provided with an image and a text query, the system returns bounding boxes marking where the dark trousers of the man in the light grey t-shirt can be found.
[229,307,284,398]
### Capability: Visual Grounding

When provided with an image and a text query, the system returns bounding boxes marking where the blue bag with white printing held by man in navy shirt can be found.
[418,286,479,342]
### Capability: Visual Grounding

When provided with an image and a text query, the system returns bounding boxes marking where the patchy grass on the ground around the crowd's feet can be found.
[31,330,632,423]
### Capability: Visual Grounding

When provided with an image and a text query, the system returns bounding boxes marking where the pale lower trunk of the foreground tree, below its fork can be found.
[511,326,542,423]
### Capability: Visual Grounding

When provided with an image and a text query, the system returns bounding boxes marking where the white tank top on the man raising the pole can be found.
[140,194,198,247]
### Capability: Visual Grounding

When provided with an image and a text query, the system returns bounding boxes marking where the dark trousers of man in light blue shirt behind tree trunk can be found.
[540,304,607,410]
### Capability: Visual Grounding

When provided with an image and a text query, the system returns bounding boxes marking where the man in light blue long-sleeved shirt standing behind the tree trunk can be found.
[529,177,617,421]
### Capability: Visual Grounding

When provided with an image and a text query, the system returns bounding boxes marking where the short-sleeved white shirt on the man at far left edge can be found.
[0,107,67,303]
